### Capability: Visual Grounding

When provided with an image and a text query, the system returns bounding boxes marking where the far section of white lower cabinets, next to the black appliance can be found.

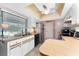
[22,38,34,55]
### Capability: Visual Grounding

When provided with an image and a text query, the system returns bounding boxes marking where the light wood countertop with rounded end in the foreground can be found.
[39,37,79,56]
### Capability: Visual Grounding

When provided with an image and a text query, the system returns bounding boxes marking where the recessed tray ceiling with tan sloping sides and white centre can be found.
[26,3,64,20]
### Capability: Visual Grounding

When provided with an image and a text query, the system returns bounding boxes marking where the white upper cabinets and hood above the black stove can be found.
[65,4,79,27]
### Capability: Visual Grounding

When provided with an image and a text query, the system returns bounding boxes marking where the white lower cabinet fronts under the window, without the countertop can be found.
[7,37,34,56]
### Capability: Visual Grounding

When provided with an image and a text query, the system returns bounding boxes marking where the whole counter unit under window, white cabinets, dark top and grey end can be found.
[0,35,34,56]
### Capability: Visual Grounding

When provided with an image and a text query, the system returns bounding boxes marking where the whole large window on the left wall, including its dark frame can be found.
[0,10,27,38]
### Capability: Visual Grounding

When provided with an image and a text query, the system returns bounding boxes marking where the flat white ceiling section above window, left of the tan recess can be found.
[0,3,31,17]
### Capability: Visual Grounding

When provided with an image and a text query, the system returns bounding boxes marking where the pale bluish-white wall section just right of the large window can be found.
[27,16,40,33]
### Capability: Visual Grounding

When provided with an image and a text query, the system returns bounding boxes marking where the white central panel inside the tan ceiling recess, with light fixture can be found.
[35,3,55,14]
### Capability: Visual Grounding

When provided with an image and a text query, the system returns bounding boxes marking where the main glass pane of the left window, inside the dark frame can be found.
[3,12,25,37]
